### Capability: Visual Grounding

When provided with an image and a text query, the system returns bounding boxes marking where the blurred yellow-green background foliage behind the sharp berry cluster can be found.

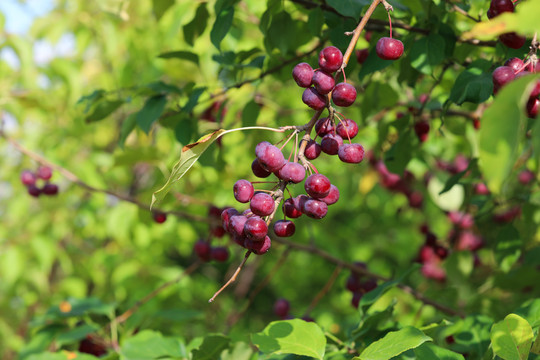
[0,0,540,359]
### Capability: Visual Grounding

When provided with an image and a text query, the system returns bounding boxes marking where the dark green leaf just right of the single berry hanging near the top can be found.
[409,34,445,75]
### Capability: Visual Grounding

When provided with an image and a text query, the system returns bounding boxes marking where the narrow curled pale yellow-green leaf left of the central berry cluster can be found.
[150,129,225,208]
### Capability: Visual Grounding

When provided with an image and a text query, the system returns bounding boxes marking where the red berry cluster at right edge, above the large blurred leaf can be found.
[492,58,540,119]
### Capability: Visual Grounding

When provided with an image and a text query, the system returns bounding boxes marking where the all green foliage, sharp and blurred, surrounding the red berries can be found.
[0,0,540,360]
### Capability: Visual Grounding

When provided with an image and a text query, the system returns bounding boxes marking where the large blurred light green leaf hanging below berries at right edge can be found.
[479,76,540,194]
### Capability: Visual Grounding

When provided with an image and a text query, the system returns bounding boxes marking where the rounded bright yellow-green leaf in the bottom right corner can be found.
[491,314,534,360]
